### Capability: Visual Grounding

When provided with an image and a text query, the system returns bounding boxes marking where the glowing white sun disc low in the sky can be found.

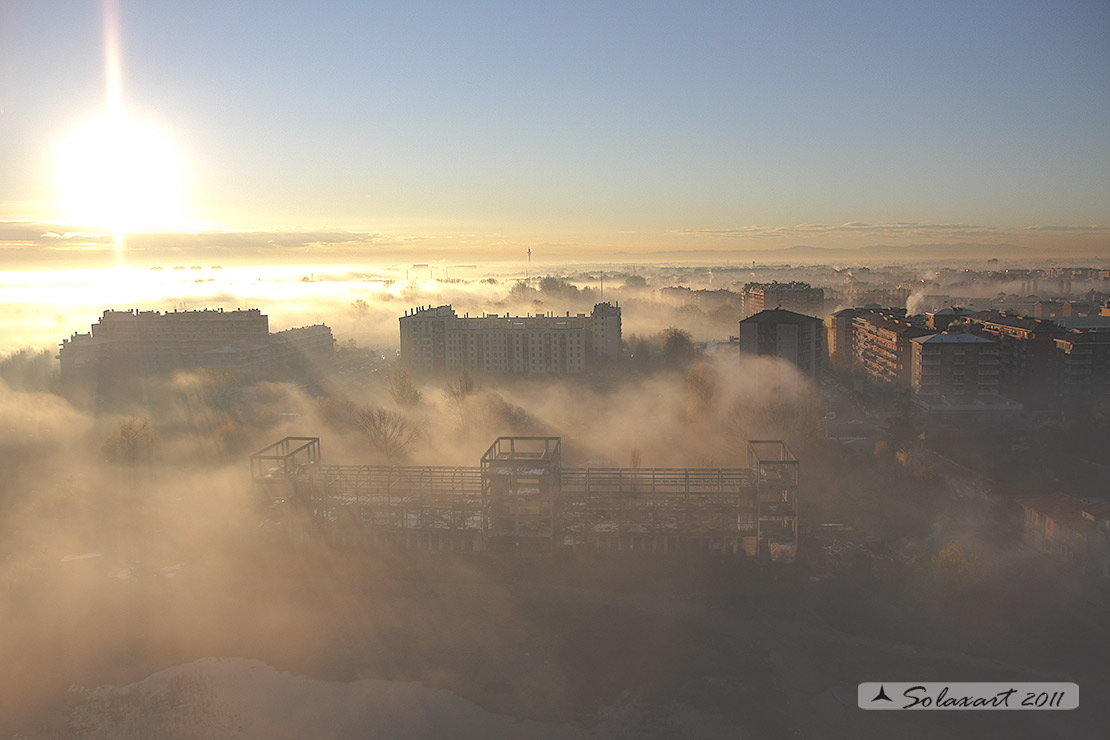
[54,112,183,236]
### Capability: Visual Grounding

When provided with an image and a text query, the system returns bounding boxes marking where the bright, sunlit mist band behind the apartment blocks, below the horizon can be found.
[0,264,781,354]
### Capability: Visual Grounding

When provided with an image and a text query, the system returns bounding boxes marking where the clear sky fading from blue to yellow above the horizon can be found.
[0,0,1110,262]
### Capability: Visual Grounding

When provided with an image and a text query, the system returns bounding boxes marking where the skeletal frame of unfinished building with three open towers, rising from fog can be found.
[251,437,799,561]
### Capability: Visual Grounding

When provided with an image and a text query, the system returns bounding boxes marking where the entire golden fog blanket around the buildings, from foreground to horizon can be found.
[0,262,1107,738]
